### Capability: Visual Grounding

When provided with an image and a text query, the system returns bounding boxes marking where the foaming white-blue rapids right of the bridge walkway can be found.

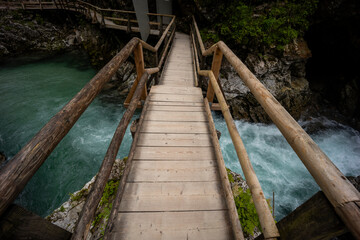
[213,113,360,220]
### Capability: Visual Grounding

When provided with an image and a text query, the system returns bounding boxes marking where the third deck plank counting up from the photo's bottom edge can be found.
[127,159,219,182]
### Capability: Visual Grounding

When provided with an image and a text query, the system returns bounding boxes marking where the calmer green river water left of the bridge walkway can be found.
[0,52,138,216]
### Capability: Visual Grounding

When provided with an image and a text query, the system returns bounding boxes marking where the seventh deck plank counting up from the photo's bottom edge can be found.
[145,111,207,122]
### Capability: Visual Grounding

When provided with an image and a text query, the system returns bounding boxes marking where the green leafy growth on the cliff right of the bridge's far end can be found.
[201,0,318,50]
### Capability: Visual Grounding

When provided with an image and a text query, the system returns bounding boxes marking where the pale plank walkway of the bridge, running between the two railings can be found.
[110,33,233,240]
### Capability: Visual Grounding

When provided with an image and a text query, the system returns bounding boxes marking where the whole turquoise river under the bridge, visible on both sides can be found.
[0,52,360,220]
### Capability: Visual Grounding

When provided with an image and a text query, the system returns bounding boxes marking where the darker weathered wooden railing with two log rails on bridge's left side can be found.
[0,10,175,239]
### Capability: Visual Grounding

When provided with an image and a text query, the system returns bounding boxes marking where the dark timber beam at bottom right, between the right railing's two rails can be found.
[256,191,349,240]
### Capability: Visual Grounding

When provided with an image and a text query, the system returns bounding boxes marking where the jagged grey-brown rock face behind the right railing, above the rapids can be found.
[212,39,311,123]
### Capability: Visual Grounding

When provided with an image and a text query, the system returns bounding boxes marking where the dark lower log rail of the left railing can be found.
[71,72,149,240]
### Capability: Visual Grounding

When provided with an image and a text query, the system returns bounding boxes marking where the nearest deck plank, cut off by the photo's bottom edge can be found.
[113,211,233,240]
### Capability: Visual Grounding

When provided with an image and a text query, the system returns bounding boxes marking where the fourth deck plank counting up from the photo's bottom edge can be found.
[134,147,215,161]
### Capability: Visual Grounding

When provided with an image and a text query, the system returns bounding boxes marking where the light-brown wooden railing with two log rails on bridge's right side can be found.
[192,17,360,239]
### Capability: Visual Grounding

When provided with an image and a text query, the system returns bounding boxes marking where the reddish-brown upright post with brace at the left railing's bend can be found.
[124,43,147,107]
